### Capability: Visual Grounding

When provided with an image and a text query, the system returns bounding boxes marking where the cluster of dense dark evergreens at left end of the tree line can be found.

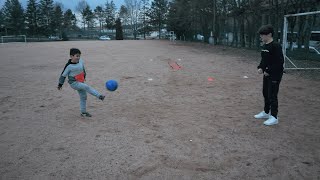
[0,0,77,36]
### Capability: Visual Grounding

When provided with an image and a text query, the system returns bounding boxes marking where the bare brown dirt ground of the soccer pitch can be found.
[0,40,320,180]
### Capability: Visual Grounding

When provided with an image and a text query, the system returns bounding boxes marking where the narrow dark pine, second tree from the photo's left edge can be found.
[25,0,40,35]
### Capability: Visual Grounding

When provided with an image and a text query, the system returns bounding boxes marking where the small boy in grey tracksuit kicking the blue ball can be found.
[58,48,105,117]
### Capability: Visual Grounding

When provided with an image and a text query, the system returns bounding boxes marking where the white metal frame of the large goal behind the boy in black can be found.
[282,11,320,69]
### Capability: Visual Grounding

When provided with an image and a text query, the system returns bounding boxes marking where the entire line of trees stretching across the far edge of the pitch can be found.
[0,0,320,47]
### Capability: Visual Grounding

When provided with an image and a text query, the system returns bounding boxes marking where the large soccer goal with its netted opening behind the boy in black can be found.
[282,11,320,70]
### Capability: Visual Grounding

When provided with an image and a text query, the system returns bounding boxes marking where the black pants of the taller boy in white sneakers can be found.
[262,76,281,118]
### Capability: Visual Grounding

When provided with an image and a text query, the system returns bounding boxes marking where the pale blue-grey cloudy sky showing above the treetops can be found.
[0,0,124,11]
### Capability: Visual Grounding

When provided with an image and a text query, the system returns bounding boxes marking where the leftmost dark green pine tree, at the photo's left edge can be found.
[2,0,24,35]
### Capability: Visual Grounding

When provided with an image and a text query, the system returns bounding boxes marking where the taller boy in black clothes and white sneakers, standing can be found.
[254,25,284,126]
